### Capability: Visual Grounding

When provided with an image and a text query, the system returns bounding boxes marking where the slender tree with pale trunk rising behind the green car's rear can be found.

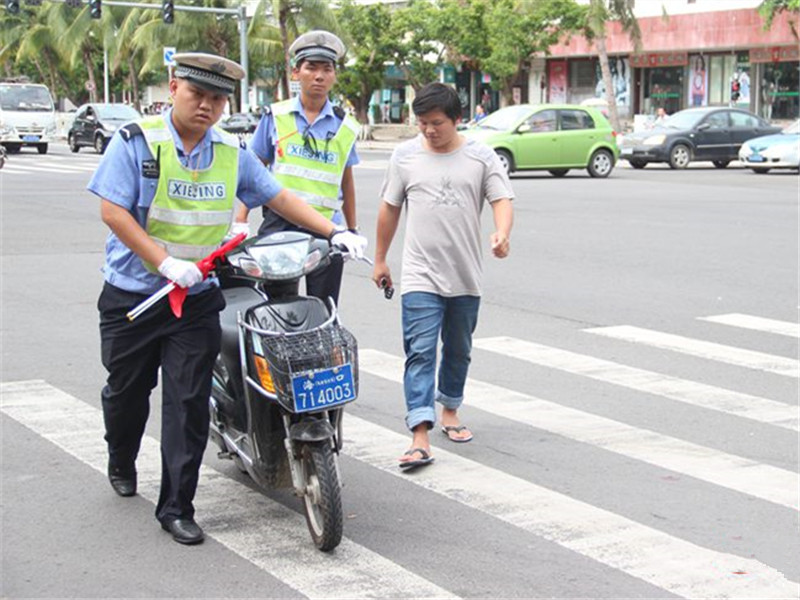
[584,0,642,131]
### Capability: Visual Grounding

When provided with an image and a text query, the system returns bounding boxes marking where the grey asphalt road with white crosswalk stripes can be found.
[0,146,800,598]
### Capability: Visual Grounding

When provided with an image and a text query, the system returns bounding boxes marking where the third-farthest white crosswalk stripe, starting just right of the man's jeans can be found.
[473,336,800,431]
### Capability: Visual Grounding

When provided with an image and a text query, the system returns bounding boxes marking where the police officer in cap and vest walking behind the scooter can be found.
[237,31,360,302]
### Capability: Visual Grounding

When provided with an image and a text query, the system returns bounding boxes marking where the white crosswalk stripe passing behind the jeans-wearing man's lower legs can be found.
[359,349,800,510]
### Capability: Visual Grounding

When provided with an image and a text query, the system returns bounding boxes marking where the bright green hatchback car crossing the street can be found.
[461,104,619,177]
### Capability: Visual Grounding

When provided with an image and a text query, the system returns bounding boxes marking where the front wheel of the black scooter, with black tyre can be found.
[301,441,344,552]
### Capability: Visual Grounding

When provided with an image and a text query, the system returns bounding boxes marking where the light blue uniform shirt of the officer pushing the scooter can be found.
[86,109,283,294]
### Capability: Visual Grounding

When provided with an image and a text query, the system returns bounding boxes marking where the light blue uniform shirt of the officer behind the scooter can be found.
[250,96,360,229]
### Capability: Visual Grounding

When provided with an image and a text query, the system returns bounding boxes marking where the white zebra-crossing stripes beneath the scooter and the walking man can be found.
[0,313,800,598]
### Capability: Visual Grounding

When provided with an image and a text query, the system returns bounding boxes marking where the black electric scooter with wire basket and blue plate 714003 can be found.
[210,232,358,551]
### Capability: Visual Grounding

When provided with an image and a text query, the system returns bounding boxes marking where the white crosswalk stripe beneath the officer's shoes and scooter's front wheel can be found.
[0,381,457,598]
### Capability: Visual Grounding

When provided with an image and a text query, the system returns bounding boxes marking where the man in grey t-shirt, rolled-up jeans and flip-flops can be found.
[372,83,514,470]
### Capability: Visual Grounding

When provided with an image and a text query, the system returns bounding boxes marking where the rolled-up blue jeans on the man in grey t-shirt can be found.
[403,292,481,429]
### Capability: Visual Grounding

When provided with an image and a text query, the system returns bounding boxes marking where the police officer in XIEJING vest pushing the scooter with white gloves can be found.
[88,53,366,544]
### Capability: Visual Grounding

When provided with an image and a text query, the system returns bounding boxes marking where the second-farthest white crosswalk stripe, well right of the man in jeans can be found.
[583,325,800,378]
